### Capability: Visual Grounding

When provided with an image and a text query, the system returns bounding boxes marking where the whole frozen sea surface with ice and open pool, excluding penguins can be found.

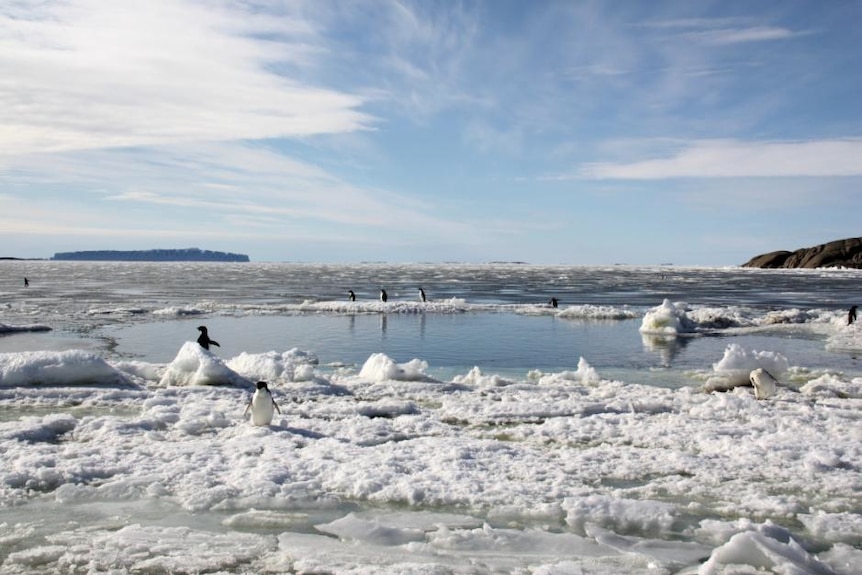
[0,262,862,574]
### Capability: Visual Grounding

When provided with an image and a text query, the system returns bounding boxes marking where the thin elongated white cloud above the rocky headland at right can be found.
[578,139,862,180]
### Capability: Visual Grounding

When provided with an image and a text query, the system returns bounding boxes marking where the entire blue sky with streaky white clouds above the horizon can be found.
[0,0,862,265]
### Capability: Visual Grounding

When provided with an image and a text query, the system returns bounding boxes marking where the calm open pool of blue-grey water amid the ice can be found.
[98,313,860,387]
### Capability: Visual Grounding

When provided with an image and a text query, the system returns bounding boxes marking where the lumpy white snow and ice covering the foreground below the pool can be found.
[0,342,862,574]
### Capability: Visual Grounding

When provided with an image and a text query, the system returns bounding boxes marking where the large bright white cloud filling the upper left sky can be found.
[0,0,372,154]
